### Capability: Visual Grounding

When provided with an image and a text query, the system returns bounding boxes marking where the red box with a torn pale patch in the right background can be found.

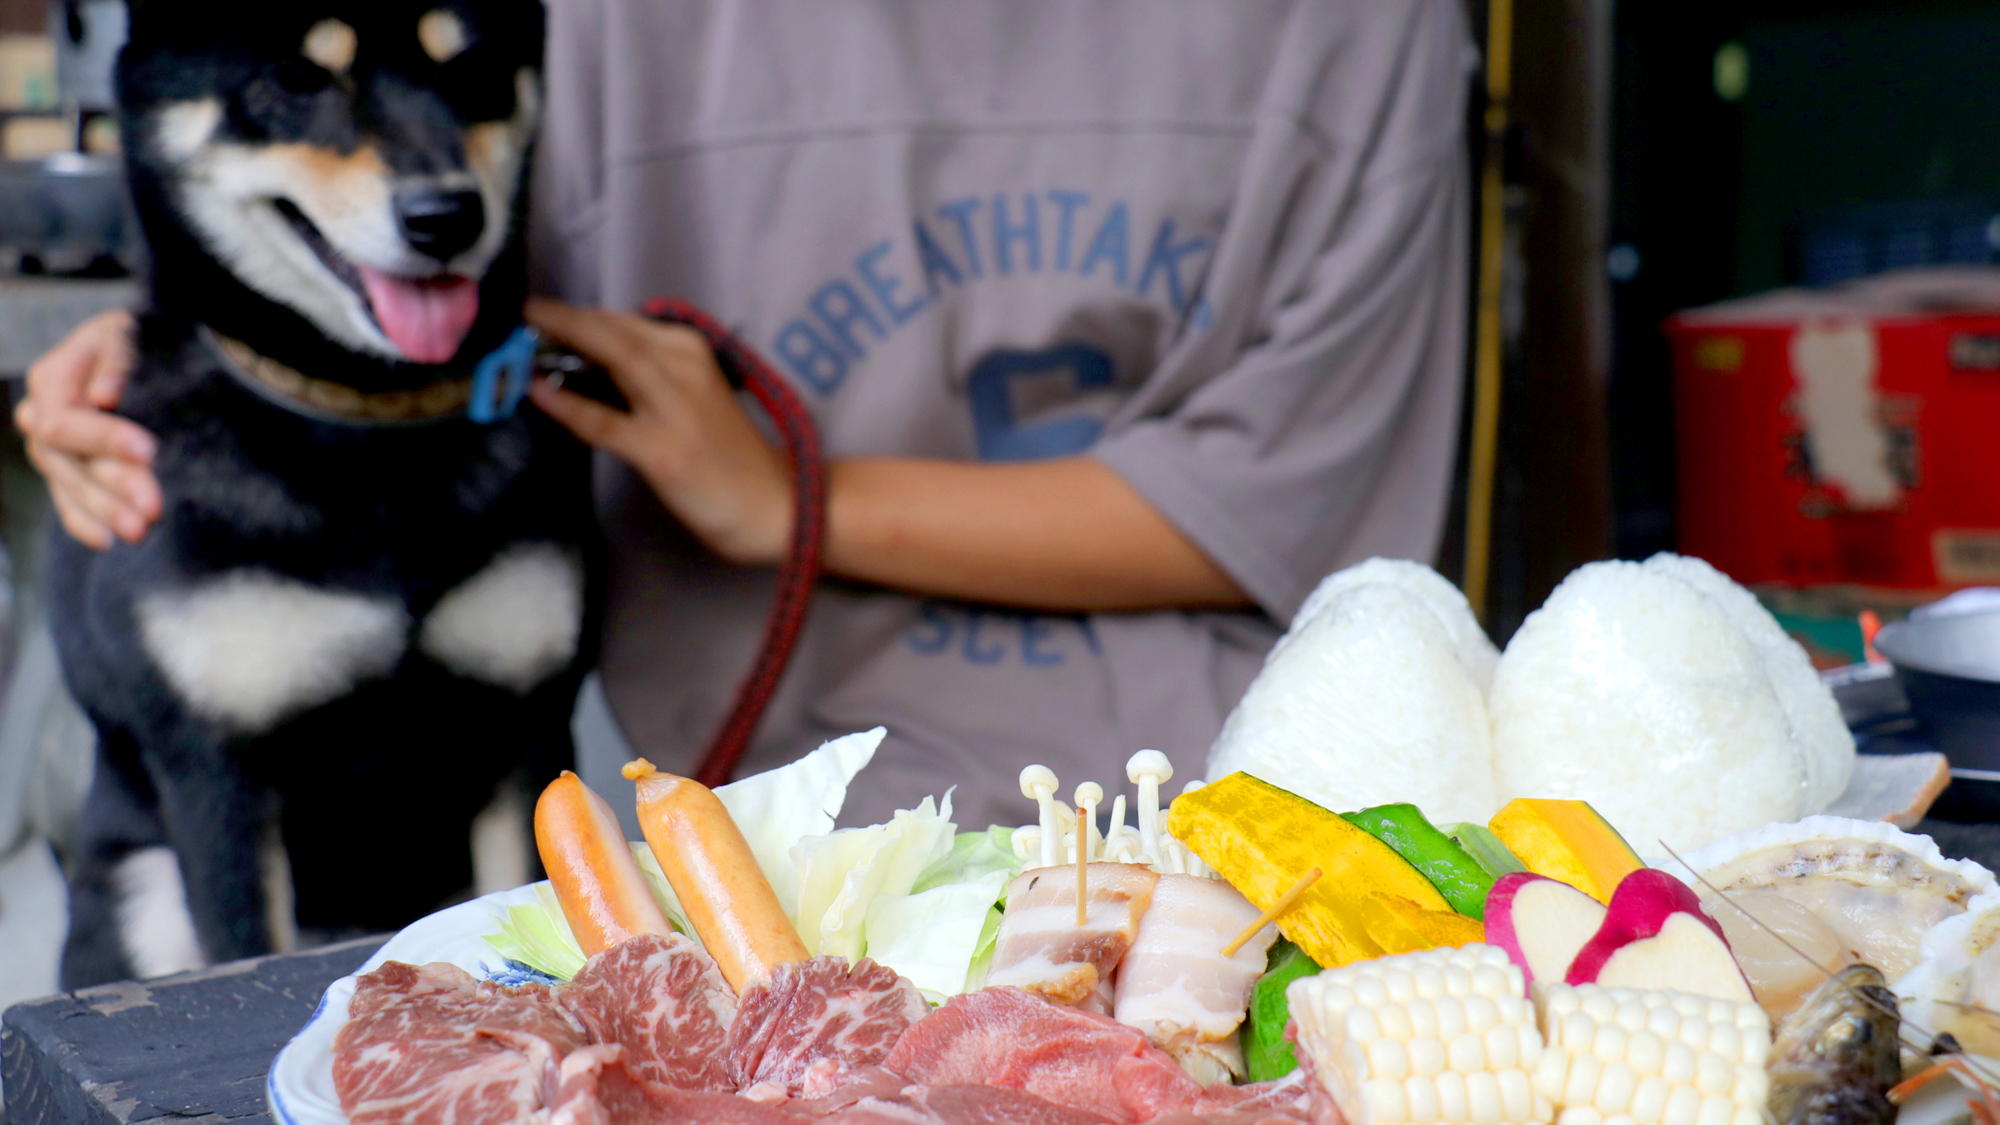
[1668,268,2000,589]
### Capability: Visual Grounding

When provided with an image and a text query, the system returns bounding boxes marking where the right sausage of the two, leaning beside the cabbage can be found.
[624,759,810,993]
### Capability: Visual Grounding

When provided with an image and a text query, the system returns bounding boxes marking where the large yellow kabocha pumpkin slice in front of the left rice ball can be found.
[1166,773,1486,967]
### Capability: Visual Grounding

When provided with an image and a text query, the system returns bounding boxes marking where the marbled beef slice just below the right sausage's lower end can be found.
[726,957,930,1099]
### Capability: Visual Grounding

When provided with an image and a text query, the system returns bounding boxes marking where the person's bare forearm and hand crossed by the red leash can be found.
[528,300,1246,611]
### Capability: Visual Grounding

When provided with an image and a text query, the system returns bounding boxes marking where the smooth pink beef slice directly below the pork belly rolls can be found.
[882,989,1202,1121]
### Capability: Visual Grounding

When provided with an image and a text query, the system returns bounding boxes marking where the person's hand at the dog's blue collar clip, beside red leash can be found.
[528,298,792,565]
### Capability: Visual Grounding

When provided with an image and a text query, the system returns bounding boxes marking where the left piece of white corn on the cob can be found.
[1284,945,1556,1125]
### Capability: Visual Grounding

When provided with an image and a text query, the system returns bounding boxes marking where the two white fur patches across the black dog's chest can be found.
[138,542,584,733]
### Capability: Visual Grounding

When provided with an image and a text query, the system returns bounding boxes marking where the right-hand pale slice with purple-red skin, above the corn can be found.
[1566,869,1754,1003]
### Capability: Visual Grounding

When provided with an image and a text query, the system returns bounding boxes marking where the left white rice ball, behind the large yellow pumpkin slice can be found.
[1208,560,1498,823]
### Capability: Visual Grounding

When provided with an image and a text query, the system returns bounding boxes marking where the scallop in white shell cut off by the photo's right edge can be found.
[1896,891,2000,1057]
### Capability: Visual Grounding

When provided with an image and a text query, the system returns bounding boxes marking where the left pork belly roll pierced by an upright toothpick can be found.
[986,863,1160,1005]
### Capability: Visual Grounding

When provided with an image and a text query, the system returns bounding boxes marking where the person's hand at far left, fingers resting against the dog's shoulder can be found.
[14,312,160,550]
